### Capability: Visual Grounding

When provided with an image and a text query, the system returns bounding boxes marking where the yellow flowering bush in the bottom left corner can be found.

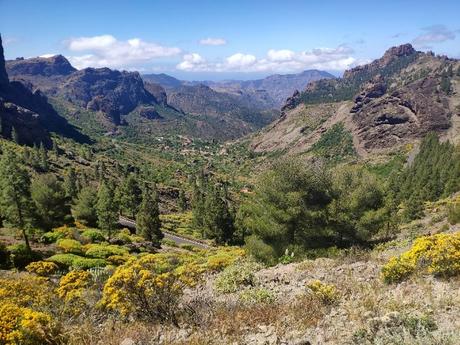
[0,303,63,345]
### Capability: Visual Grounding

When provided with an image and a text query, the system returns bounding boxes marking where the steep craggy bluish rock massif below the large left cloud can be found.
[59,68,155,125]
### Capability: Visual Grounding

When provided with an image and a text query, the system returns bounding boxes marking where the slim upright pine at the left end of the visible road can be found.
[96,181,119,238]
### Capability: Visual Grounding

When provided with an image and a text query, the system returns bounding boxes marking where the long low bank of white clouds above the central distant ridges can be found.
[176,45,357,72]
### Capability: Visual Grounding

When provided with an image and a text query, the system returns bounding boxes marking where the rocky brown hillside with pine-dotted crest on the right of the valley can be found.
[251,45,460,156]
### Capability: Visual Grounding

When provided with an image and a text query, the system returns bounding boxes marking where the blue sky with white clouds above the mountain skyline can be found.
[0,0,460,80]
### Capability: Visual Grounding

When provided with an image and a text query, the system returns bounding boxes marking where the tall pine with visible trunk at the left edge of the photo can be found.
[0,151,35,250]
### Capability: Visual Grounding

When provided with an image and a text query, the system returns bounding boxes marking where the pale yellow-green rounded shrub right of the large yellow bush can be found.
[215,260,261,293]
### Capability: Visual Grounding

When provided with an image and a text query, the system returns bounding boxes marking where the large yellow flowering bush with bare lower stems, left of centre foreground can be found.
[100,253,202,324]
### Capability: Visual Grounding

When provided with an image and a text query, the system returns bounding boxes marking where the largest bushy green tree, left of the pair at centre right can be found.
[239,159,333,255]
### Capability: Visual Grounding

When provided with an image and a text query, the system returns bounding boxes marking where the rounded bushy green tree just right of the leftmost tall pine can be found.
[31,174,70,230]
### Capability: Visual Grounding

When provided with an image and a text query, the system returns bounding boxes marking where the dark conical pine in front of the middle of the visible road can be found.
[136,187,164,246]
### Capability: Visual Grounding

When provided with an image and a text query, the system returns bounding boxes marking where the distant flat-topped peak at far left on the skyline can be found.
[6,55,76,77]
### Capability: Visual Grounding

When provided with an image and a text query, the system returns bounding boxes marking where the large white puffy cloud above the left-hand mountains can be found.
[65,35,181,69]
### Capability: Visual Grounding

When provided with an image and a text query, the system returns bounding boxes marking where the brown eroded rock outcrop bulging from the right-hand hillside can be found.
[351,77,451,149]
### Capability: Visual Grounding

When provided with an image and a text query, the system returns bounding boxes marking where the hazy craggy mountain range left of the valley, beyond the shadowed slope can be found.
[6,55,277,141]
